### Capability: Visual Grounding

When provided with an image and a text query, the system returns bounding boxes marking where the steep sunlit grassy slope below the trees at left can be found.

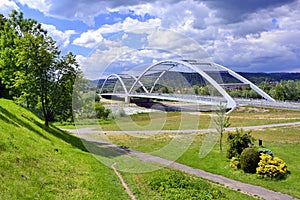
[0,99,128,199]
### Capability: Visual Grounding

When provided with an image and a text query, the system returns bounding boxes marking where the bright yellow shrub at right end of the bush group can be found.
[256,154,288,179]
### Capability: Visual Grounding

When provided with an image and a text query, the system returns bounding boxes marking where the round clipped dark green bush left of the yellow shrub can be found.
[240,148,260,173]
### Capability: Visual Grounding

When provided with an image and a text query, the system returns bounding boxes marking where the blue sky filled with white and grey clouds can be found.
[0,0,300,79]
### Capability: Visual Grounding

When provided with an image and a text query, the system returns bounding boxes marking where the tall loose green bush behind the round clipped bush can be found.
[226,129,254,159]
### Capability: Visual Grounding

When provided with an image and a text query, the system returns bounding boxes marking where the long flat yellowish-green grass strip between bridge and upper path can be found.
[85,106,300,131]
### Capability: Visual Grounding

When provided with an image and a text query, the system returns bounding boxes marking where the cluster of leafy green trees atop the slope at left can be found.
[0,11,81,126]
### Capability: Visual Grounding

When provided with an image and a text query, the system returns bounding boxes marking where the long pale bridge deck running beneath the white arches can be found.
[100,93,300,110]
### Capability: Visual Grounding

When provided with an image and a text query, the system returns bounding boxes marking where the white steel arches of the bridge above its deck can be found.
[100,60,275,109]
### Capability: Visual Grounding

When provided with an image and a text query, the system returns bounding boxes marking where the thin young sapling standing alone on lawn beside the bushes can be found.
[214,103,230,151]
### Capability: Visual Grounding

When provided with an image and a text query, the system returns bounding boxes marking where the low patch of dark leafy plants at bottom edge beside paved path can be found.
[148,172,225,200]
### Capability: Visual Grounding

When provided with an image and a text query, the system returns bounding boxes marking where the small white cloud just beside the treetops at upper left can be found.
[42,24,76,48]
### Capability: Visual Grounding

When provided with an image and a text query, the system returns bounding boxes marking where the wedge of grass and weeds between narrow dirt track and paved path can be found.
[123,168,254,200]
